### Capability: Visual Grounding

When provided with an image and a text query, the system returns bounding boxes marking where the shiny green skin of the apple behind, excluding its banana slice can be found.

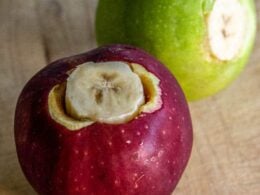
[96,0,256,101]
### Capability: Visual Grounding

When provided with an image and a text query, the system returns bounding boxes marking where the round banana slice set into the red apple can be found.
[65,62,145,124]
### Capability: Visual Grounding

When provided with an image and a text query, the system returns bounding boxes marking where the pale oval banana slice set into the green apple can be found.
[208,0,247,61]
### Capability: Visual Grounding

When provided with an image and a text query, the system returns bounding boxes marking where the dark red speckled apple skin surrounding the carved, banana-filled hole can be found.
[15,45,192,195]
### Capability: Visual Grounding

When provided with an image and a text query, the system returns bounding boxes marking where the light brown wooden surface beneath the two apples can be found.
[0,0,260,195]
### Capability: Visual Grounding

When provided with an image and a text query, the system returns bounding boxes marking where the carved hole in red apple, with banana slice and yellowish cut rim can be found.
[48,62,162,130]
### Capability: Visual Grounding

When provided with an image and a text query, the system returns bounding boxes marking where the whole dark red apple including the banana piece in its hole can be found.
[15,45,192,195]
